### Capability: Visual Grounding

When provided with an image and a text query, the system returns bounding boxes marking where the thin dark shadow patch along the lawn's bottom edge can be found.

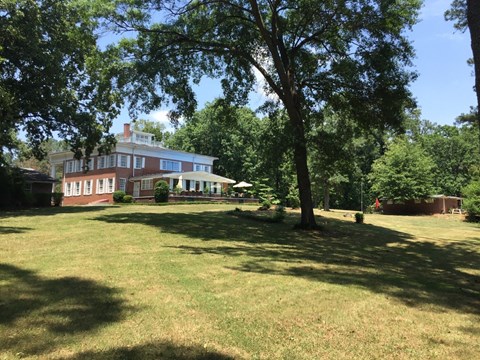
[63,342,233,360]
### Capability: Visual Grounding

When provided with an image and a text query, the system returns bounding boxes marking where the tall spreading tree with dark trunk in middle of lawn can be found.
[106,0,420,228]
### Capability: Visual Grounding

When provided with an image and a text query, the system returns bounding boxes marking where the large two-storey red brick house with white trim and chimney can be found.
[50,124,235,205]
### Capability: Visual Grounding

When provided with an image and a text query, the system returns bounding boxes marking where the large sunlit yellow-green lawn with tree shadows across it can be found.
[0,205,480,359]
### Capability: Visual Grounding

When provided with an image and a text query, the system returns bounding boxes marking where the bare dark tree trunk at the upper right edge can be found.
[467,0,480,147]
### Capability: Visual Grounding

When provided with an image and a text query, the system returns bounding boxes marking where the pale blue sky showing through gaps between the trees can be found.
[112,0,476,133]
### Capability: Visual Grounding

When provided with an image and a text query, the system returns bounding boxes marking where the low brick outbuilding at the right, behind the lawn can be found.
[382,195,462,215]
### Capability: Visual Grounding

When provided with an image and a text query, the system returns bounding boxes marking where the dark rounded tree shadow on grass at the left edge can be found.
[0,264,131,355]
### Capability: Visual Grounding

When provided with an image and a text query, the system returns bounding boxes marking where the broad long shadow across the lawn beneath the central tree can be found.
[96,212,480,314]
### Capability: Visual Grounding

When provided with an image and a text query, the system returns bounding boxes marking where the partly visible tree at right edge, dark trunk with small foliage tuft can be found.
[445,0,480,148]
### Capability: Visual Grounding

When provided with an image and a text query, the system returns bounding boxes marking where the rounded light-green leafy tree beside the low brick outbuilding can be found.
[369,137,435,201]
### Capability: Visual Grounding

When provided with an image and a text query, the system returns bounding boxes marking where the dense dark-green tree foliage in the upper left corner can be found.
[0,0,119,161]
